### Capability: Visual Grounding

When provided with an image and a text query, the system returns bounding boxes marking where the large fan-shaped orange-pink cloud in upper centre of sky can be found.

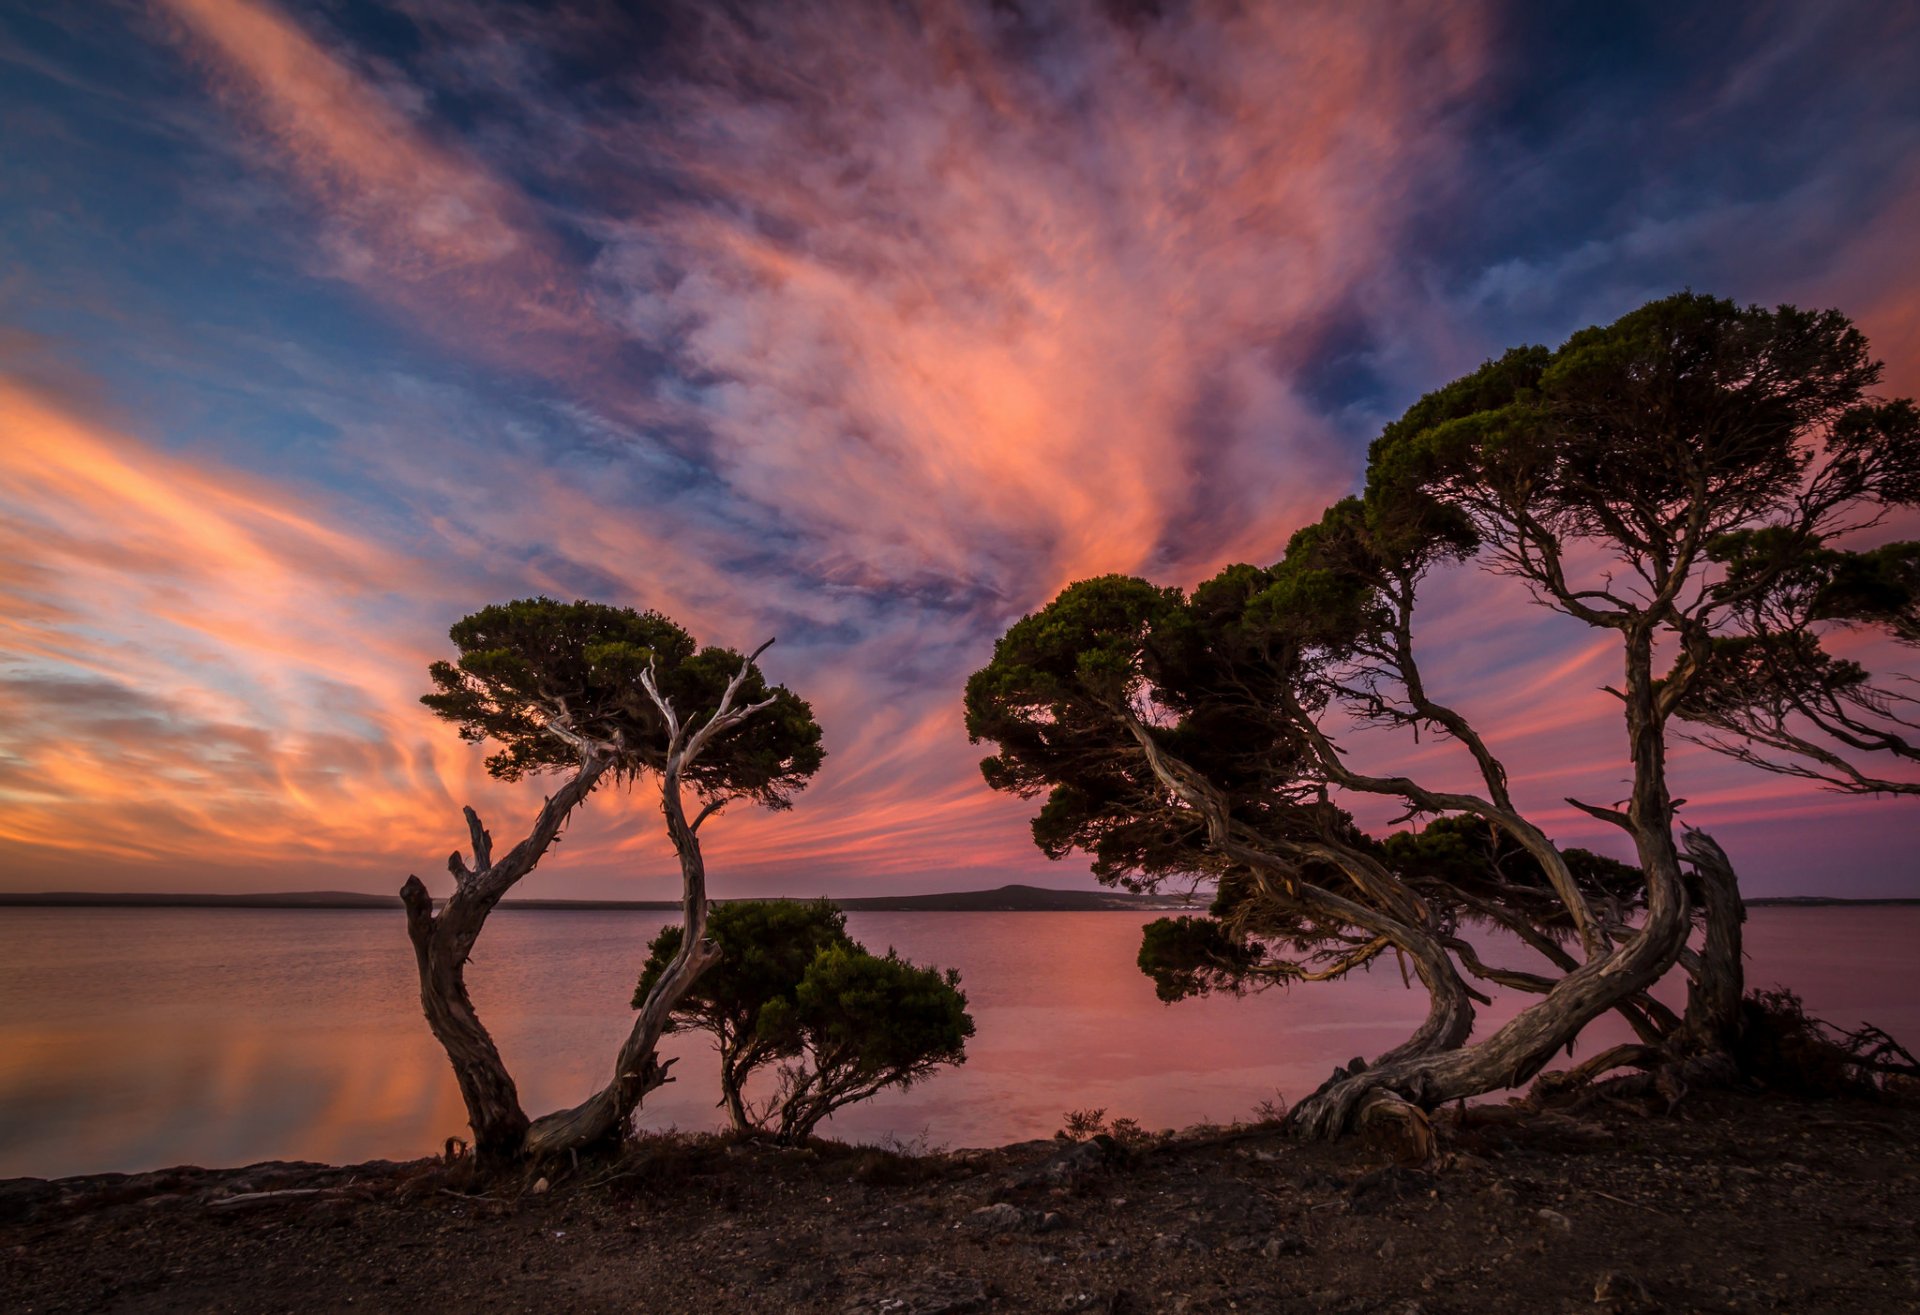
[599,6,1478,591]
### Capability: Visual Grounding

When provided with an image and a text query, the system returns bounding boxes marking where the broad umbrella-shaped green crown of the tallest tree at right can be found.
[1367,292,1920,591]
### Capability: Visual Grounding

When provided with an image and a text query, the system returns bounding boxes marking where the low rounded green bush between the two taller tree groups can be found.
[634,900,973,1144]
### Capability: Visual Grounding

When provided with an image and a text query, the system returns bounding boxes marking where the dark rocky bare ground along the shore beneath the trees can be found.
[0,1096,1920,1315]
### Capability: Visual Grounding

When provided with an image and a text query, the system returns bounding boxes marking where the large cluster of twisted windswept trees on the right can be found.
[968,294,1920,1135]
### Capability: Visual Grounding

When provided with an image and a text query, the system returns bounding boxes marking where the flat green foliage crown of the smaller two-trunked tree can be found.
[420,599,824,808]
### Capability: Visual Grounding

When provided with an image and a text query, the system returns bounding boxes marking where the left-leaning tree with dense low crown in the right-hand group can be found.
[966,566,1475,1105]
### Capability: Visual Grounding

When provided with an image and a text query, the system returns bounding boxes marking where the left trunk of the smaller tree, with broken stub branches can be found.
[399,756,609,1165]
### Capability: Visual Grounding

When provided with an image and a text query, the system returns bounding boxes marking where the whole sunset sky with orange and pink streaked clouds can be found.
[0,0,1920,898]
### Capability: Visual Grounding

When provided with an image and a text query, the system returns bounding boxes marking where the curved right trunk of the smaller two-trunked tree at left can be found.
[526,764,720,1158]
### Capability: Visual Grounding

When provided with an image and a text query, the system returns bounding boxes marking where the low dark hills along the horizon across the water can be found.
[0,885,1188,914]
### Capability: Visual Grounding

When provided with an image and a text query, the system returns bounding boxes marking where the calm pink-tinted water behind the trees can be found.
[0,908,1920,1177]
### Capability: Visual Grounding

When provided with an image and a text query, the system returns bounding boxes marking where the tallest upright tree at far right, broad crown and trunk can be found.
[1367,294,1920,1062]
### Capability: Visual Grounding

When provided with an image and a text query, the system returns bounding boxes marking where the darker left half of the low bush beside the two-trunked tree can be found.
[634,900,852,1133]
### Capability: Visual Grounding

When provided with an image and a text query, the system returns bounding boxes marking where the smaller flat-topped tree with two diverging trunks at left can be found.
[401,599,824,1163]
